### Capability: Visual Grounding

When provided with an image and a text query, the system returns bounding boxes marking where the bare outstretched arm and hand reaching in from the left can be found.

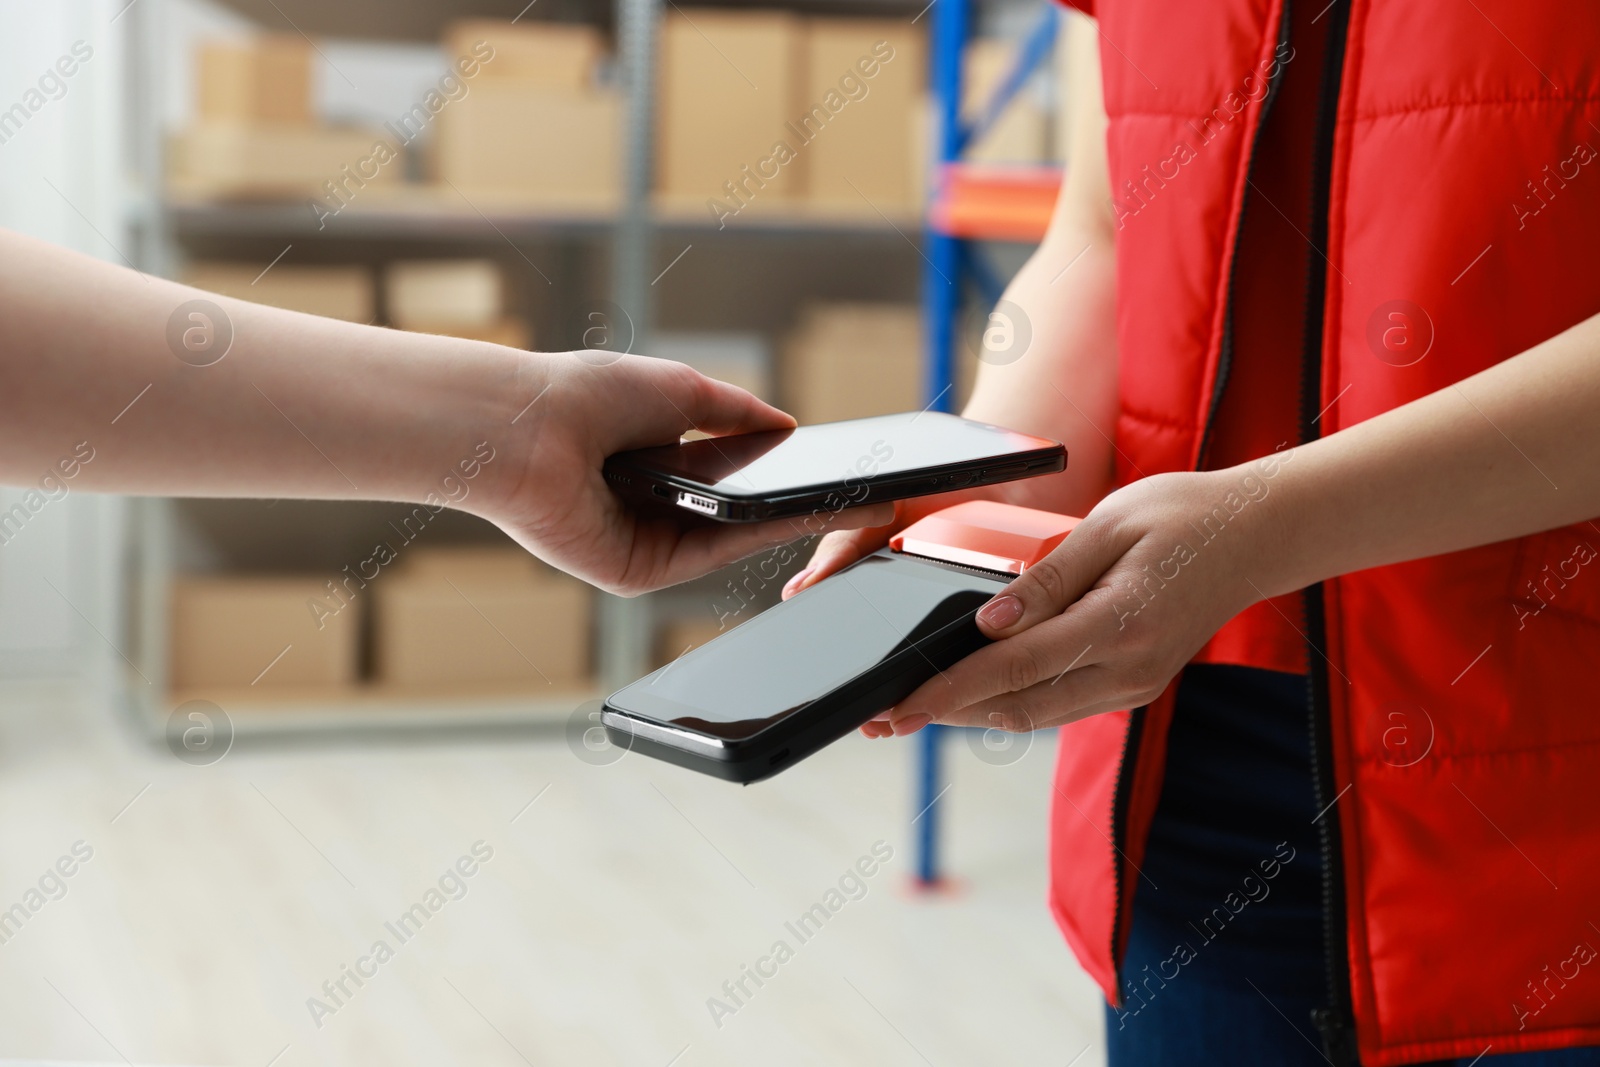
[0,232,888,593]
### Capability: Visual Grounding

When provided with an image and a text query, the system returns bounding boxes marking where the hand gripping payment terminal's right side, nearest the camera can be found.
[862,469,1282,737]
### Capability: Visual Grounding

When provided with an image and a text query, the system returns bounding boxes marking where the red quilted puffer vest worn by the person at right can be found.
[1051,0,1600,1064]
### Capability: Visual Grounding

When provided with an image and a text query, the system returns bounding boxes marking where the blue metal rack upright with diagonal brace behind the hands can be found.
[912,0,1058,888]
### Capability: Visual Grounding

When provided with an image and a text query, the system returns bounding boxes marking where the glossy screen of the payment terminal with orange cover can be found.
[608,555,1008,741]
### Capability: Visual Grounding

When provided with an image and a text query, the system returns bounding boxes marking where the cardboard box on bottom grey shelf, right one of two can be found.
[373,571,594,693]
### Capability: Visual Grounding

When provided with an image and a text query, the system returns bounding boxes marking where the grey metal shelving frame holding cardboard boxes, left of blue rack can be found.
[125,0,922,736]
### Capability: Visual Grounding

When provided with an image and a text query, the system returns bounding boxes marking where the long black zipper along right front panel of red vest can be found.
[1299,0,1360,1067]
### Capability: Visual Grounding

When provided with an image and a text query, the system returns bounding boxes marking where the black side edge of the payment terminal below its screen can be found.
[602,588,992,785]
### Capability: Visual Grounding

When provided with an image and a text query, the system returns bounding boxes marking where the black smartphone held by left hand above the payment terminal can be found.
[605,411,1067,523]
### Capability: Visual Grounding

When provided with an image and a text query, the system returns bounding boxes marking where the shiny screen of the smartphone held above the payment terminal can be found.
[629,411,1059,498]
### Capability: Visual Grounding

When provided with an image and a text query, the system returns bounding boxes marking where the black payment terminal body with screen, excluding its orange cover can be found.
[600,549,1013,784]
